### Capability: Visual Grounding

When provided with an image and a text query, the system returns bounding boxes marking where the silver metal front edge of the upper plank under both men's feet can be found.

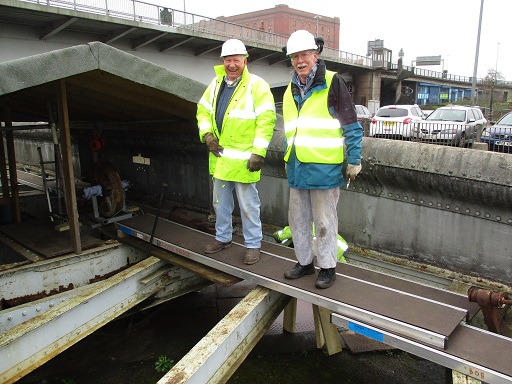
[117,224,448,349]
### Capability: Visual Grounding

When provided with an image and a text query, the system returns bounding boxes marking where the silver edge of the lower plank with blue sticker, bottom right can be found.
[331,313,512,384]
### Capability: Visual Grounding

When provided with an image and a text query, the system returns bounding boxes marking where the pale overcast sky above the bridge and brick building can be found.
[154,0,512,81]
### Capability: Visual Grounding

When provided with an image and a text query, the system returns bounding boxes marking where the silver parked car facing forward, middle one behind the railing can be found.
[420,105,487,147]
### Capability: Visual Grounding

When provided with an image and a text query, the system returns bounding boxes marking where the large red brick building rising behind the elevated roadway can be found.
[217,4,340,50]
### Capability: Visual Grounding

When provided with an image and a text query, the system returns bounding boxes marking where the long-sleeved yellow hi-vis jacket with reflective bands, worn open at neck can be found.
[197,65,276,183]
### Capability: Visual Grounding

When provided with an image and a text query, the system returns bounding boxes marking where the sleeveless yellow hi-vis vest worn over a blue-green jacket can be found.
[283,71,344,164]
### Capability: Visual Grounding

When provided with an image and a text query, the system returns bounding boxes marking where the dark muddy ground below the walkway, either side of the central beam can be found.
[19,280,451,384]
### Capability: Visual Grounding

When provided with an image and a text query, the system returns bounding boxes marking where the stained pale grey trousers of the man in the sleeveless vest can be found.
[288,188,340,268]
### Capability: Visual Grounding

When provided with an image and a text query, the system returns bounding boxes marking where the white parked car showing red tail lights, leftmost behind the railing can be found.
[369,104,425,139]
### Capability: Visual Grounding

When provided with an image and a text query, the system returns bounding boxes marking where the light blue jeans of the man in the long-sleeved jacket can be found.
[213,178,263,248]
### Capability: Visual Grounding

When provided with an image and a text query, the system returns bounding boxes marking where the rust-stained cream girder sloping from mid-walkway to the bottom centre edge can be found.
[158,286,290,384]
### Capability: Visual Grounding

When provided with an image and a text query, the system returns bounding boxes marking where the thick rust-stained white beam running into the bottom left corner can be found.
[0,257,208,383]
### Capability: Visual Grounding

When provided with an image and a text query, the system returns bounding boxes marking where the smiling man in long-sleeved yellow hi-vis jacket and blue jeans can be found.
[197,39,276,264]
